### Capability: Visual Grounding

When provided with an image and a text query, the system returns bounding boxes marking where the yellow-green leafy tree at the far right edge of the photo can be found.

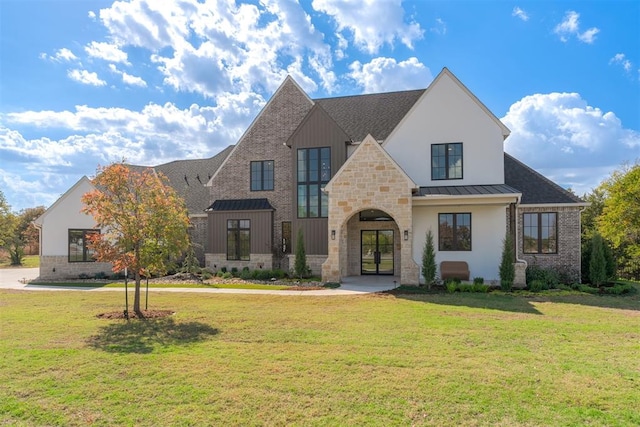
[597,161,640,280]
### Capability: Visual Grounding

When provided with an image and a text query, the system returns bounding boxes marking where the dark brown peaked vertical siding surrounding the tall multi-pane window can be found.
[289,106,349,255]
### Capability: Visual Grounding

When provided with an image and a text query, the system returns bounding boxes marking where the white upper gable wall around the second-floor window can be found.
[384,73,504,186]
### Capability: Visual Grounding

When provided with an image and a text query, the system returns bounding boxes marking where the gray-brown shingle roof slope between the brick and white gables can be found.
[314,89,425,142]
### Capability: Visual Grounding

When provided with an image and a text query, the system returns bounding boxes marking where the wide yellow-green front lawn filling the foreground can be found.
[0,290,640,426]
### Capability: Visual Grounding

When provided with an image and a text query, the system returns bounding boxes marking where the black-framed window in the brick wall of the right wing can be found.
[522,212,558,254]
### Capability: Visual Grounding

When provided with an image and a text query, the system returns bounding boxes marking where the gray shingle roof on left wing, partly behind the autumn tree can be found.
[128,145,233,215]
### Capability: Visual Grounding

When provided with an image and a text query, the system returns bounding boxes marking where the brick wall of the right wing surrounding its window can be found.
[507,205,581,281]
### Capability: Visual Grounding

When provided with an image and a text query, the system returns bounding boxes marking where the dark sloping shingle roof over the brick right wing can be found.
[504,153,584,205]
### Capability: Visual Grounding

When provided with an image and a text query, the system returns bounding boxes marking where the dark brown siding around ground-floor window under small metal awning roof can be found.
[208,211,273,254]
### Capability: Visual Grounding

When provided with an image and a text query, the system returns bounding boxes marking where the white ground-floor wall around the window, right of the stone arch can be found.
[412,205,507,282]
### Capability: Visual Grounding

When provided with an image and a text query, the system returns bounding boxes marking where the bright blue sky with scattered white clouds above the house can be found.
[0,0,640,211]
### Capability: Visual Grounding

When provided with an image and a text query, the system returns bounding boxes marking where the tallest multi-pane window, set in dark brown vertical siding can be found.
[298,147,331,218]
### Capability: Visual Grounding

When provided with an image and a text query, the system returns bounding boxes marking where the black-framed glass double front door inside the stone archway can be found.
[360,230,393,275]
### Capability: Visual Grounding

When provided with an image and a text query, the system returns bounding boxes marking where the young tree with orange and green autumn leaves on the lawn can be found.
[82,163,189,315]
